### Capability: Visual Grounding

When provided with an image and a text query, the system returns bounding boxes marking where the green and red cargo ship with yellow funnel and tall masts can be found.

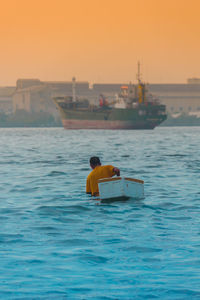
[54,63,167,129]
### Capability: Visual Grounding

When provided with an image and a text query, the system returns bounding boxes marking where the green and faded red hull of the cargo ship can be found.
[54,102,166,129]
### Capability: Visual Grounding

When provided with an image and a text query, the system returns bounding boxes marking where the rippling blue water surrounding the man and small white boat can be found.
[0,127,200,299]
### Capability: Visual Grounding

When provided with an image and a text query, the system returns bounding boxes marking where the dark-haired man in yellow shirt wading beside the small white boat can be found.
[86,156,120,196]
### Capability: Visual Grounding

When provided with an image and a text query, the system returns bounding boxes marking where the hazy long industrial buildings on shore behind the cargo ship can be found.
[0,78,200,122]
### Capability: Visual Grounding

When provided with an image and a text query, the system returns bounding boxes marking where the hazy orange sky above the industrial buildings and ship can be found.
[0,0,200,86]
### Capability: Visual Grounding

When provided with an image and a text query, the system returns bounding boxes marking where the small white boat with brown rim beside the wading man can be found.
[98,177,144,201]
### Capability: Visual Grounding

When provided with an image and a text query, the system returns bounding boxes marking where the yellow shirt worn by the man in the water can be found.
[86,166,115,196]
